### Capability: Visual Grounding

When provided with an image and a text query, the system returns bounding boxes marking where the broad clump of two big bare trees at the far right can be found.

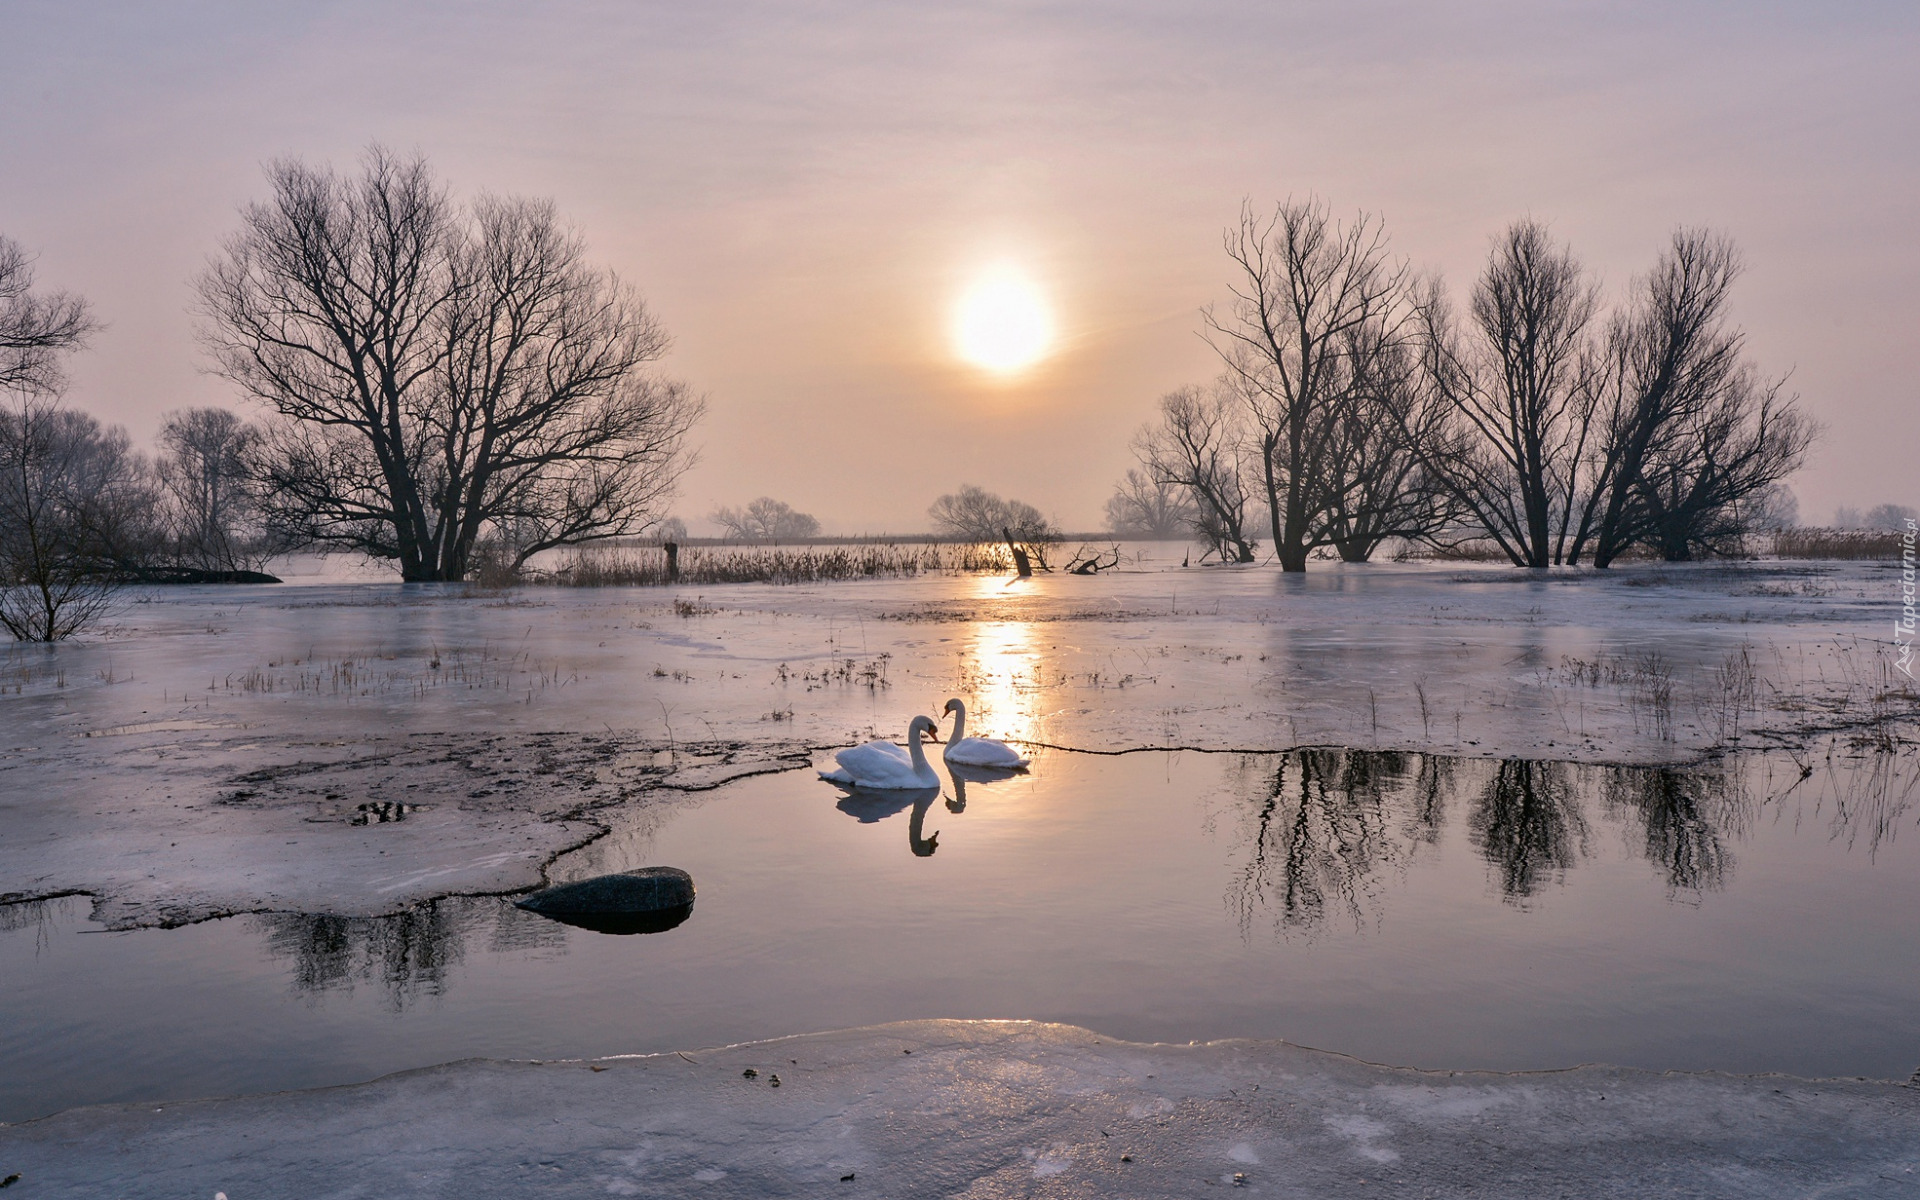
[1409,221,1816,566]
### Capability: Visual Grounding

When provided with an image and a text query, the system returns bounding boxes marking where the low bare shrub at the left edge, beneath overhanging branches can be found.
[0,396,157,641]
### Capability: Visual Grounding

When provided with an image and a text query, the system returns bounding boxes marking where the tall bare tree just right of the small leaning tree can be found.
[1206,198,1405,570]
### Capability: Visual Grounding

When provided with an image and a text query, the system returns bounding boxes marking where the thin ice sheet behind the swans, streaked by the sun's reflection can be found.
[0,563,1916,927]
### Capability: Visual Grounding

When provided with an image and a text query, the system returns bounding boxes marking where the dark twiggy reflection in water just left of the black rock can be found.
[259,897,566,1012]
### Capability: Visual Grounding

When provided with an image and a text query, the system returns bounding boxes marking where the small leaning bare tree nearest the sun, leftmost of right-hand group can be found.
[1133,382,1256,563]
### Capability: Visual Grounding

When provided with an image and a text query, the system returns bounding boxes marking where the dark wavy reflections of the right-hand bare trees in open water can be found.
[1227,749,1755,935]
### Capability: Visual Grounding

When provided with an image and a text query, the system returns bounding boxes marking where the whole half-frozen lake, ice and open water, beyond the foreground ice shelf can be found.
[0,557,1920,1119]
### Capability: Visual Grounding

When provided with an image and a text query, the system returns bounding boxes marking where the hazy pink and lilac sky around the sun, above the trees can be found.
[0,0,1920,532]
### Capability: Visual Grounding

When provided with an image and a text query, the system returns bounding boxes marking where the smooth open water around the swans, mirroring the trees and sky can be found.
[0,749,1920,1119]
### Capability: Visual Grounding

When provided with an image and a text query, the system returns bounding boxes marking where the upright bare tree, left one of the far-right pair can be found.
[1415,221,1599,566]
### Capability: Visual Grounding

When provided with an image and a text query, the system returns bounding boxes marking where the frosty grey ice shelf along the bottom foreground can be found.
[0,1021,1920,1200]
